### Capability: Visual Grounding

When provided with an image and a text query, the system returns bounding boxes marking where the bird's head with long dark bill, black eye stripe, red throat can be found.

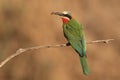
[51,11,72,23]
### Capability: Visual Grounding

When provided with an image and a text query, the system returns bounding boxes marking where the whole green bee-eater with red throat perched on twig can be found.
[51,11,90,75]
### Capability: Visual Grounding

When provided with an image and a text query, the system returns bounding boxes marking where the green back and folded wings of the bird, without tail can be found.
[63,19,86,56]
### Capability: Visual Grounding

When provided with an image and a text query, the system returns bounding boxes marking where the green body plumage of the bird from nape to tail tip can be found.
[63,19,90,75]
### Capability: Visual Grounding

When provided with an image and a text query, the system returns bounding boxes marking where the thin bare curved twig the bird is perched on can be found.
[0,39,114,68]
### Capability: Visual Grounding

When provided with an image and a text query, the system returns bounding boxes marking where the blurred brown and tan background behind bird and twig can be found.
[0,0,120,80]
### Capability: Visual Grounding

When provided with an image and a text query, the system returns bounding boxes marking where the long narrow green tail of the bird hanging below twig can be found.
[80,56,90,75]
